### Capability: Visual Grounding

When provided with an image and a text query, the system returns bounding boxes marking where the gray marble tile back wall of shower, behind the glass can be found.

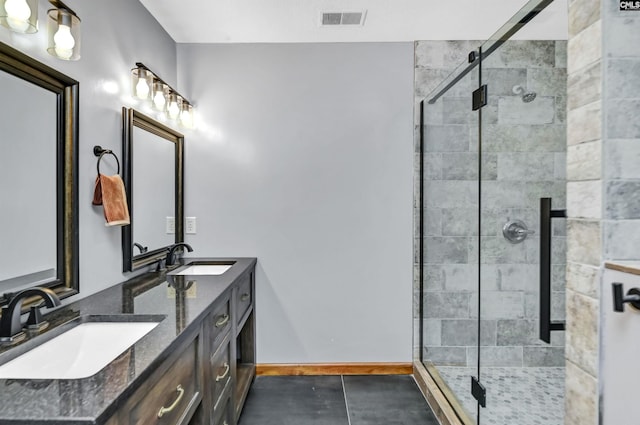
[416,41,566,366]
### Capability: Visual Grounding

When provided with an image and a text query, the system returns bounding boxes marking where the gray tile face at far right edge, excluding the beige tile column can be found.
[603,2,640,261]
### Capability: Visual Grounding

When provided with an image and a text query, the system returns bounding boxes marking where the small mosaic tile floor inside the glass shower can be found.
[438,366,564,425]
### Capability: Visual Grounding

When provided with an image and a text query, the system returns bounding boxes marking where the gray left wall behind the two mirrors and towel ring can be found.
[0,0,176,301]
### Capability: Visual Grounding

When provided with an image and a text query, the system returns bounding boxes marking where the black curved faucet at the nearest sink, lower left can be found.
[0,288,60,342]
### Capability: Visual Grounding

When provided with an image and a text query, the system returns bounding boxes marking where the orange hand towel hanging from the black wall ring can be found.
[93,174,131,226]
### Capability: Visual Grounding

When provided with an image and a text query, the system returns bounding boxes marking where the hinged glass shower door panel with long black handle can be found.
[475,2,566,425]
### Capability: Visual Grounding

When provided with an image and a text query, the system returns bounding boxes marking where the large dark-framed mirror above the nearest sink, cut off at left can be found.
[0,43,79,304]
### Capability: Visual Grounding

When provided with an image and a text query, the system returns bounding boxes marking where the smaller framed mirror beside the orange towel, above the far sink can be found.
[122,108,184,271]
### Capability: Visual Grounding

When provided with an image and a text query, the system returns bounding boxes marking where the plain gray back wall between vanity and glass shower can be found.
[178,43,413,363]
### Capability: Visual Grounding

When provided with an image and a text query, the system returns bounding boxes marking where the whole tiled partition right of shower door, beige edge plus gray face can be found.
[565,0,640,425]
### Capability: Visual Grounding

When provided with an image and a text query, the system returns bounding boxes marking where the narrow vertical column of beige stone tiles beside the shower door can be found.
[564,0,604,425]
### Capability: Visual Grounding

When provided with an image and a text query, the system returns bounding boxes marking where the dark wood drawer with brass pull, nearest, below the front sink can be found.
[127,339,200,425]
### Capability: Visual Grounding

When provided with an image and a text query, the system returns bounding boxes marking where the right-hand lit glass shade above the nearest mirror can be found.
[47,9,80,61]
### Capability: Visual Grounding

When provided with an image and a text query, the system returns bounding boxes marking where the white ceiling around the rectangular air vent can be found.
[140,0,567,43]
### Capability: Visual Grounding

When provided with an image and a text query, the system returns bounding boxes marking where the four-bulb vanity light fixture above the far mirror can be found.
[131,62,194,128]
